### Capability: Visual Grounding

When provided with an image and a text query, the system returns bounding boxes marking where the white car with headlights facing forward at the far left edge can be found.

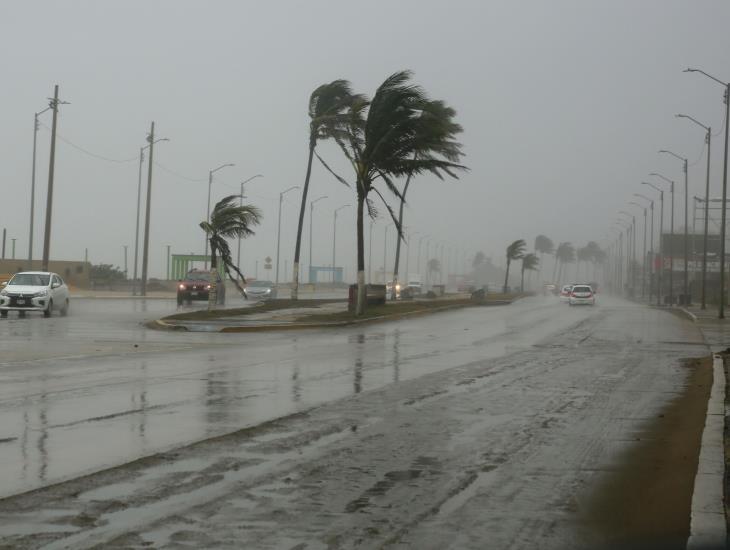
[0,271,68,317]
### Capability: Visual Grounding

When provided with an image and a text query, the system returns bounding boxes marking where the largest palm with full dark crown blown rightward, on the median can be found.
[325,71,466,315]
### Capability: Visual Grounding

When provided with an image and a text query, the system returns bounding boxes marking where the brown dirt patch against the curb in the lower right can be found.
[585,357,712,550]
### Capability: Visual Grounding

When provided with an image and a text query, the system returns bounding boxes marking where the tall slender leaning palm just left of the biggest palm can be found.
[291,80,358,300]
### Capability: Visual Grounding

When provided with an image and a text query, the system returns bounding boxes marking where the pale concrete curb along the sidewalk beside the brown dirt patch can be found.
[687,356,727,550]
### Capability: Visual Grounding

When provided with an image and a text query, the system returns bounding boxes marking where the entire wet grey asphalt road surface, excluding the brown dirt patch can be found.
[0,298,707,549]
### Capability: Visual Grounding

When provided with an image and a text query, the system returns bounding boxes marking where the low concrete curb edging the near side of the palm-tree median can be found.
[146,296,521,333]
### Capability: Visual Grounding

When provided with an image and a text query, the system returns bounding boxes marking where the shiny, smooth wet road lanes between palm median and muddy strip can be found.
[0,298,601,496]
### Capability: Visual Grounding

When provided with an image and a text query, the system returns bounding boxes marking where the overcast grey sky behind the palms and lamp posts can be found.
[0,0,730,278]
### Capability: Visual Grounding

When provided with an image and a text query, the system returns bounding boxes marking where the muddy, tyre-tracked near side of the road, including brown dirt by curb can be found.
[0,306,707,549]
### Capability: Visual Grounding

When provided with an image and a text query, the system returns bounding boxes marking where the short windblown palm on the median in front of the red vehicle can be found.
[200,195,263,309]
